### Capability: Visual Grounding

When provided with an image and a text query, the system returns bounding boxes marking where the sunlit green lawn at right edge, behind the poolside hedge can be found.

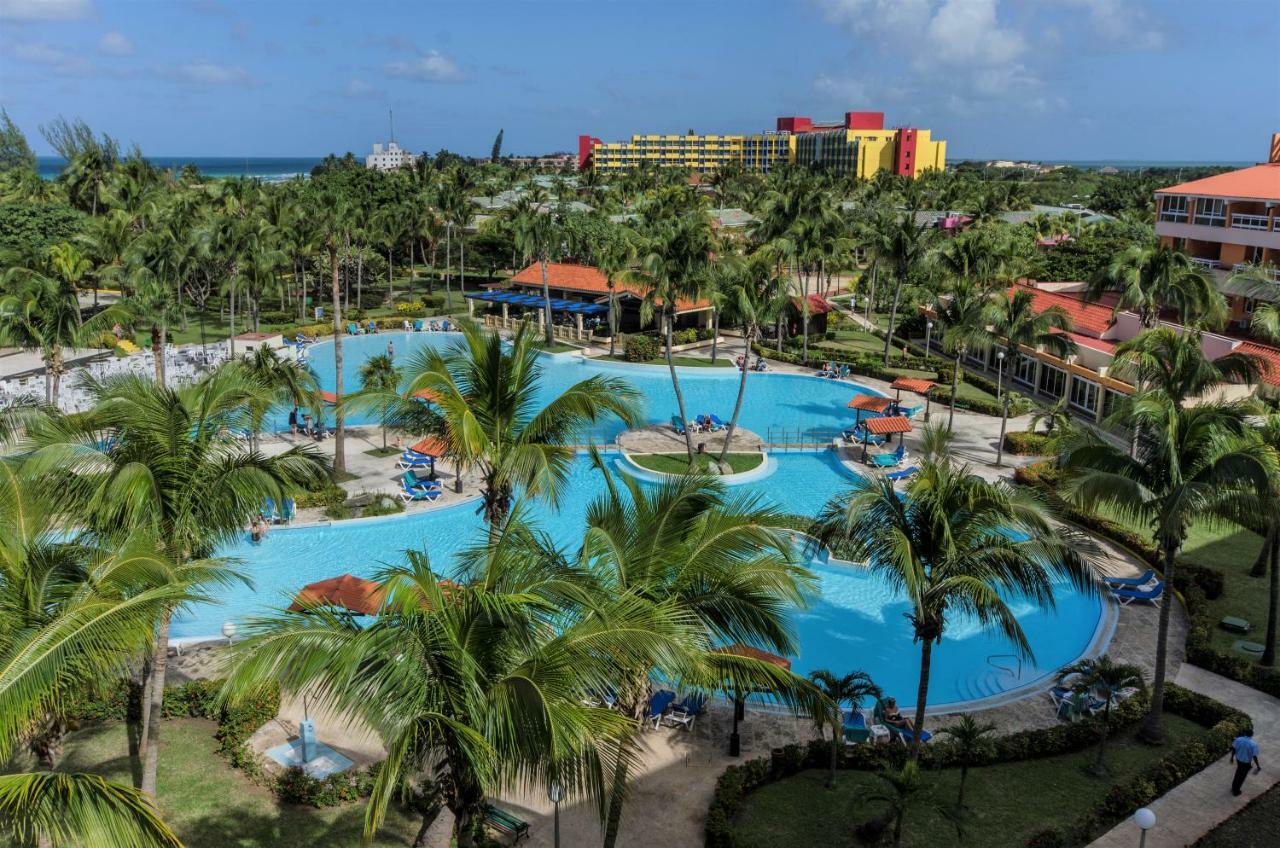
[1098,510,1267,653]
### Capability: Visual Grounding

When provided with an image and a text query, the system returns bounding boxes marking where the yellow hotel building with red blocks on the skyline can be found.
[577,111,947,178]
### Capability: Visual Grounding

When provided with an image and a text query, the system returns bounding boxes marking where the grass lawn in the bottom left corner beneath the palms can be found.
[18,719,421,848]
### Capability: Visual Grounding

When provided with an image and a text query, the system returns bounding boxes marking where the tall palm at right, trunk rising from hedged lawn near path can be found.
[1059,391,1276,742]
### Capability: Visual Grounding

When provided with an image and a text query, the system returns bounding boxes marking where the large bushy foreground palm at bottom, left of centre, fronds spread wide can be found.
[225,527,649,848]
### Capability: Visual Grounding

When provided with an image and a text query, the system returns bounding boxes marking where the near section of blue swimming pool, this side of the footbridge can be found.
[173,451,1103,707]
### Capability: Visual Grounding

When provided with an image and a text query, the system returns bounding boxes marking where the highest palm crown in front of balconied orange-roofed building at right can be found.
[1088,243,1226,329]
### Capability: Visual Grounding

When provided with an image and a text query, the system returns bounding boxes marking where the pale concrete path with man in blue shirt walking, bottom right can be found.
[1089,664,1280,848]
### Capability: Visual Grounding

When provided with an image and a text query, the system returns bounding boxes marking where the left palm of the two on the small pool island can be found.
[627,214,712,464]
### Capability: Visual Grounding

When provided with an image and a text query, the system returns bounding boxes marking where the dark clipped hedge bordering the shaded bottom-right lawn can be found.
[705,684,1251,848]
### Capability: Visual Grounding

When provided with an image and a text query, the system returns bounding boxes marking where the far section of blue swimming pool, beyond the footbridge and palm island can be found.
[294,333,879,442]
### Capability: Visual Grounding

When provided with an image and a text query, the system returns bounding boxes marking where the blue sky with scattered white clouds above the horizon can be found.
[0,0,1280,160]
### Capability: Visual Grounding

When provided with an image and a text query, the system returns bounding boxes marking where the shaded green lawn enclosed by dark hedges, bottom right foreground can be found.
[735,717,1206,848]
